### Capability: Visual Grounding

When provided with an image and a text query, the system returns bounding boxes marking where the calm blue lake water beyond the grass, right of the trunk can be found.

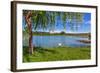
[33,36,90,47]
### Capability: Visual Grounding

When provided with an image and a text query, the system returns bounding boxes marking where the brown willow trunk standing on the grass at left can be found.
[26,11,33,54]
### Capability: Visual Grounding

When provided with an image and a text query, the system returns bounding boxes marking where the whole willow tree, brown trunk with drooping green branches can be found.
[23,10,83,54]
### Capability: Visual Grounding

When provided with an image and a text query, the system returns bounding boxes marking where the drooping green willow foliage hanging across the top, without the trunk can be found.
[23,10,83,31]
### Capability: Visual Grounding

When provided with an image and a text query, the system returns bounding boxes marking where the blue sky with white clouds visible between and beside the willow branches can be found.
[23,13,91,33]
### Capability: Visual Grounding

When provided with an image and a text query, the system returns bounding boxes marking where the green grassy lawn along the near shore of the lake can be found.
[23,46,91,62]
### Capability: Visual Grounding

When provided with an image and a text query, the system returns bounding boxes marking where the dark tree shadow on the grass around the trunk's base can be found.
[23,46,57,62]
